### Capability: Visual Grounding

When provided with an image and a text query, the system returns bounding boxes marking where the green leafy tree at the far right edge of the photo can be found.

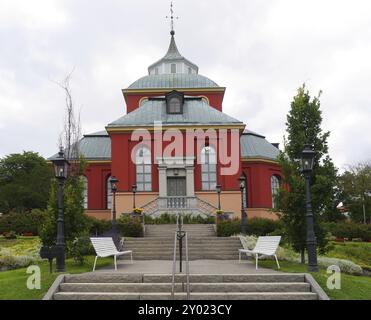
[339,162,371,223]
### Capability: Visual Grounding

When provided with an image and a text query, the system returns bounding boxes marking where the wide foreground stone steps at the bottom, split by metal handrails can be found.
[44,272,328,300]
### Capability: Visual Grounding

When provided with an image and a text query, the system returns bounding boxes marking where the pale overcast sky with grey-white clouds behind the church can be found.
[0,0,371,168]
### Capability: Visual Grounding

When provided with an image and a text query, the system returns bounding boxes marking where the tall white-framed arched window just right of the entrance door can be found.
[201,146,216,191]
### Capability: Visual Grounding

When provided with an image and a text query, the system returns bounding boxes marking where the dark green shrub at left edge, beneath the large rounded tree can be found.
[0,209,46,235]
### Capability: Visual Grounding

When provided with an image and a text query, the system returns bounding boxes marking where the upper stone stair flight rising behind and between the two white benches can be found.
[122,224,242,260]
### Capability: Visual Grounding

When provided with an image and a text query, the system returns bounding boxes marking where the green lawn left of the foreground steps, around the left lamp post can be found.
[0,256,113,300]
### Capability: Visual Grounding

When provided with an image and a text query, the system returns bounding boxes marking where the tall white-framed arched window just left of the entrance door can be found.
[135,147,152,191]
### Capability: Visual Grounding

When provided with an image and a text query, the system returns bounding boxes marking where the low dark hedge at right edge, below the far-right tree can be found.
[324,222,371,241]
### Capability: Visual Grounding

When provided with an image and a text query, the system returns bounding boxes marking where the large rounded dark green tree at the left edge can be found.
[0,152,52,213]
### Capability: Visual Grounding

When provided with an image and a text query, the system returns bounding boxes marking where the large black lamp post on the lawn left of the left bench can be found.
[51,147,69,272]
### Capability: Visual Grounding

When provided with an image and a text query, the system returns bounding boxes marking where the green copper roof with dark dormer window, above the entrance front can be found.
[108,99,243,127]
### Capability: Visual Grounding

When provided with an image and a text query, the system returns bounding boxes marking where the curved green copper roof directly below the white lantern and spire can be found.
[128,73,219,89]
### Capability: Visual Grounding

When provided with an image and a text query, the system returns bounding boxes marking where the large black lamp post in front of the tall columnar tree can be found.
[301,145,318,272]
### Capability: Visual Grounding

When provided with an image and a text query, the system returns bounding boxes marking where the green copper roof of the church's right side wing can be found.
[241,130,279,160]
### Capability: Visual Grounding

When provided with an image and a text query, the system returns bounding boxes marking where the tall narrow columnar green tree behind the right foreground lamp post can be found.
[276,85,337,262]
